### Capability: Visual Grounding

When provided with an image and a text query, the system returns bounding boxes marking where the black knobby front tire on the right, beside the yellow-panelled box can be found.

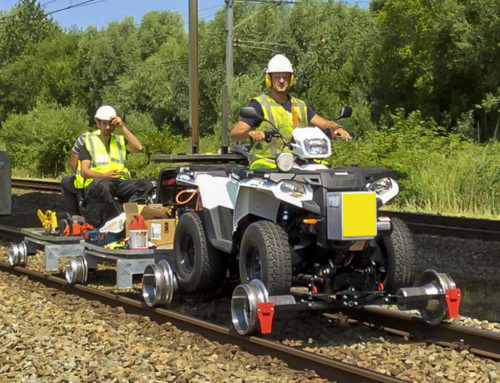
[381,218,416,293]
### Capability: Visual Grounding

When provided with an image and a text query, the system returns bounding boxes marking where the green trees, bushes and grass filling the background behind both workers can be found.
[0,0,500,219]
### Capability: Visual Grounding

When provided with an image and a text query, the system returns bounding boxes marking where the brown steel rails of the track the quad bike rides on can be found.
[0,227,500,382]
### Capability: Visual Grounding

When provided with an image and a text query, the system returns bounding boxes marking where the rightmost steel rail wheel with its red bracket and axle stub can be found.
[397,269,461,326]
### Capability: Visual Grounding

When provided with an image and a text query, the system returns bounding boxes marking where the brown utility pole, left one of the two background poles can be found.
[189,0,200,154]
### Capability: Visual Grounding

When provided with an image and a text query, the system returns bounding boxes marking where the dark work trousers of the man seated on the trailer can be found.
[84,178,153,226]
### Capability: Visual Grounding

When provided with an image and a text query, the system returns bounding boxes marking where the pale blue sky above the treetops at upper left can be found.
[0,0,225,29]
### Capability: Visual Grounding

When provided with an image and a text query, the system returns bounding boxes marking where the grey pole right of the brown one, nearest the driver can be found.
[222,0,234,153]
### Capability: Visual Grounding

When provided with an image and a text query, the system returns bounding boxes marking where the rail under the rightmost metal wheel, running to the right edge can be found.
[332,306,500,361]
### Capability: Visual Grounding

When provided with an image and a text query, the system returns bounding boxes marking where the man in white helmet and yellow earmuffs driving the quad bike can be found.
[231,54,351,170]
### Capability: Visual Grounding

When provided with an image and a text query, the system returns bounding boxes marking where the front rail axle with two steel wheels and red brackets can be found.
[231,269,461,335]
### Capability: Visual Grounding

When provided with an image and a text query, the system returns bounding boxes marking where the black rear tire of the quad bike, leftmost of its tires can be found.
[174,212,226,292]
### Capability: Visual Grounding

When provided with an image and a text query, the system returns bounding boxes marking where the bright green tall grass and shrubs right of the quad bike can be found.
[332,109,500,217]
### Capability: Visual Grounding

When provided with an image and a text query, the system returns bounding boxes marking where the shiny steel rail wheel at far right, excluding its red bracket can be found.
[415,269,456,326]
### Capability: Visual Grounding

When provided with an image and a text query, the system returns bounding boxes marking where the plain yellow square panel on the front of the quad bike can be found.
[342,193,377,237]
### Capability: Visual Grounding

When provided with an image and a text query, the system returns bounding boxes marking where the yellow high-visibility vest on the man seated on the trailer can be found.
[78,133,130,187]
